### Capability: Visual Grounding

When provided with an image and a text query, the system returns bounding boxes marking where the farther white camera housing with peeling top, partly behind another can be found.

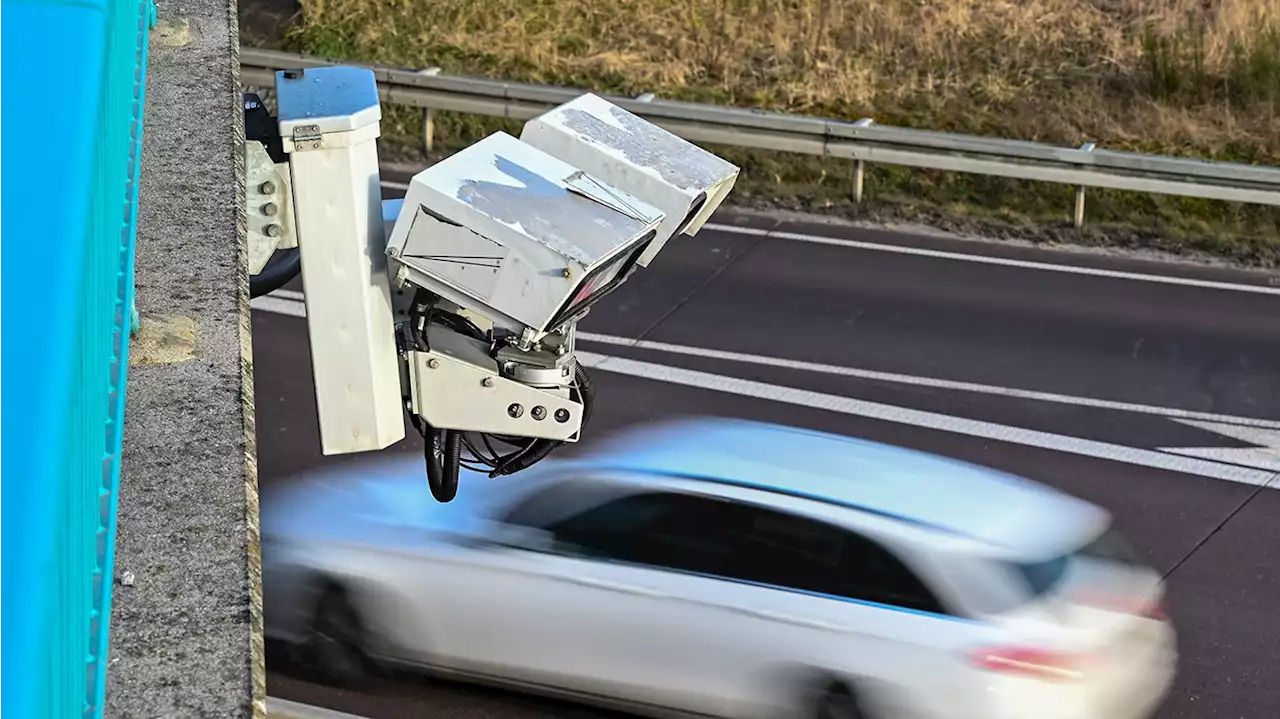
[520,93,739,266]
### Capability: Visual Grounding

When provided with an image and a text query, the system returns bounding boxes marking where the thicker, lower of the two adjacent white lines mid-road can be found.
[253,297,1276,486]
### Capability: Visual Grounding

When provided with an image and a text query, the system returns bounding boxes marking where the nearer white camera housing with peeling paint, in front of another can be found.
[387,132,666,336]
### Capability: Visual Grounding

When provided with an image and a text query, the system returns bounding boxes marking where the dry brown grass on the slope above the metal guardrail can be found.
[277,0,1280,263]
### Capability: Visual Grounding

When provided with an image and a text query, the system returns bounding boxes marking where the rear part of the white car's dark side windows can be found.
[731,507,947,614]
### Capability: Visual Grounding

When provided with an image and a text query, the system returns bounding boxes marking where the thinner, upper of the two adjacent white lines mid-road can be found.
[253,289,1280,430]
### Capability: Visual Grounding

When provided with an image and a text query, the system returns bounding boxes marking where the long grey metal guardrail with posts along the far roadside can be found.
[241,47,1280,226]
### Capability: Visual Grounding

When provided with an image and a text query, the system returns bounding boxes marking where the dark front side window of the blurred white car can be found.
[547,491,732,574]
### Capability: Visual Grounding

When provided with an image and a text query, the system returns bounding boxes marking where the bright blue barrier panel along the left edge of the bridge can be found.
[0,0,155,719]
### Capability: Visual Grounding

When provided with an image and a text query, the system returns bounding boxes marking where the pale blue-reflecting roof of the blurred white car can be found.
[584,417,1108,549]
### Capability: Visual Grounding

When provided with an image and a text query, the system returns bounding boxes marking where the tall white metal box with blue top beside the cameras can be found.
[275,67,404,454]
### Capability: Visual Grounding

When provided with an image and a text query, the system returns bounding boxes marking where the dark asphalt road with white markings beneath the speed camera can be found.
[253,180,1280,719]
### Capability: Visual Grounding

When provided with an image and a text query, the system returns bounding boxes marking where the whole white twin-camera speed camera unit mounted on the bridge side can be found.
[264,67,737,502]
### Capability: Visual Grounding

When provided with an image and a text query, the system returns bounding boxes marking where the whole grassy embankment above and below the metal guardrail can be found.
[275,0,1280,265]
